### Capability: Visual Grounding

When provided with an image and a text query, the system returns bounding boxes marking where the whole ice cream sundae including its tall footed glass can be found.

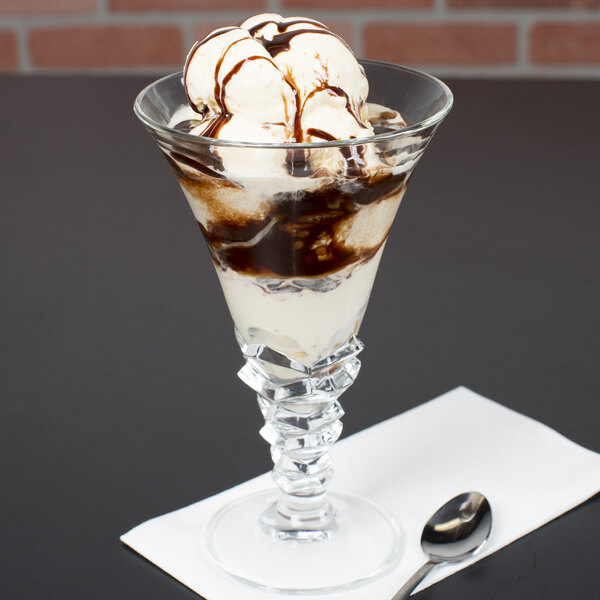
[130,14,452,594]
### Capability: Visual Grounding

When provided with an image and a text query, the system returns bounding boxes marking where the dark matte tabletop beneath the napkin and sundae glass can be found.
[0,76,600,600]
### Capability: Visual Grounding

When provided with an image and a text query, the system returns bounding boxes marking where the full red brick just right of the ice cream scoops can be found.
[364,23,517,65]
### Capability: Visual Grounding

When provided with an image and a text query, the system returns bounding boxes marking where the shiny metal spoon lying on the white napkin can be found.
[392,492,492,600]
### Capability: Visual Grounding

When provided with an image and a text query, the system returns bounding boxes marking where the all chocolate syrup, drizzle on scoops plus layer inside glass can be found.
[176,19,407,278]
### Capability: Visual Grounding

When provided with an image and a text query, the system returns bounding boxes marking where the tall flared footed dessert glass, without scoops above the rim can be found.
[135,61,452,593]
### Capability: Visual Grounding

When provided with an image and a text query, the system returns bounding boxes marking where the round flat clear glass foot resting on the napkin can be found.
[207,490,401,594]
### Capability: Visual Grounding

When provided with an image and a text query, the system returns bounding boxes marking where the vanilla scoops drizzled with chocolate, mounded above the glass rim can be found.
[176,14,402,177]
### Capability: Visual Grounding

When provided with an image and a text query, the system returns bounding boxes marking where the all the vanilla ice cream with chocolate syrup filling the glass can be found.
[163,14,423,365]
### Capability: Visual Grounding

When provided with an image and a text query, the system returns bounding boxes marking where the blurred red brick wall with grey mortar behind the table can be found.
[0,0,600,78]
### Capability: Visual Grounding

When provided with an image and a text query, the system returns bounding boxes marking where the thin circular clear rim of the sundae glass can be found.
[133,59,454,150]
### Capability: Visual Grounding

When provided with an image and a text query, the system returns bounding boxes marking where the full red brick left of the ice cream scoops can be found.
[29,25,184,68]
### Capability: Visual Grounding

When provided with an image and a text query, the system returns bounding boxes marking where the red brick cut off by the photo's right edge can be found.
[530,23,600,65]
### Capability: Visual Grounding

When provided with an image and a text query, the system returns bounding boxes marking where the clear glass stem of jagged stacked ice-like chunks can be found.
[238,337,363,541]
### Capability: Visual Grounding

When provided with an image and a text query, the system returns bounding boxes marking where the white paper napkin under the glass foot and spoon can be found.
[121,387,600,600]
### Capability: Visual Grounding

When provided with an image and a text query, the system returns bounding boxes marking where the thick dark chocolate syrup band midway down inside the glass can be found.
[198,174,406,278]
